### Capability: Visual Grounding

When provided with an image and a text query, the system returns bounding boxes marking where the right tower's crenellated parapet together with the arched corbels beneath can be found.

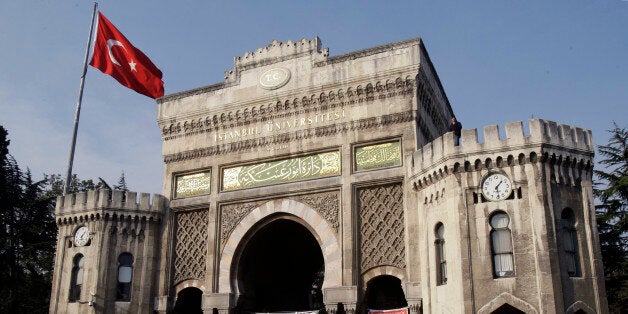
[408,119,594,189]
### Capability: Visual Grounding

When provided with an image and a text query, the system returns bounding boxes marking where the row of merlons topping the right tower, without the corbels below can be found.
[412,119,594,169]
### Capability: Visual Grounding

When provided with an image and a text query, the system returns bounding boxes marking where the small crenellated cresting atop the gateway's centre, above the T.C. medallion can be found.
[233,36,329,69]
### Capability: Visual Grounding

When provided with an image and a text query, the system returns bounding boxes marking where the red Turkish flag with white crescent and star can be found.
[89,11,164,98]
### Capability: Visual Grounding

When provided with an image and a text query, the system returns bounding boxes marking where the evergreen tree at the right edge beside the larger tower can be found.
[594,124,628,313]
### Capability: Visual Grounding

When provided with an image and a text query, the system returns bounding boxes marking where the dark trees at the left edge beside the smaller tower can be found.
[0,126,57,313]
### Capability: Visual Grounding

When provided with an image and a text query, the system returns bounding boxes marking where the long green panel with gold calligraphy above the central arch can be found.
[222,151,341,191]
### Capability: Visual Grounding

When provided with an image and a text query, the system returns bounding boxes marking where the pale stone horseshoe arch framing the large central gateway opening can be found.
[218,199,342,293]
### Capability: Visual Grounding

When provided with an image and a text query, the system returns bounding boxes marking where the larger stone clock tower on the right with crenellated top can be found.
[408,119,607,313]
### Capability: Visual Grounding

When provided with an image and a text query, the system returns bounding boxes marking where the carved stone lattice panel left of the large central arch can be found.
[173,209,209,284]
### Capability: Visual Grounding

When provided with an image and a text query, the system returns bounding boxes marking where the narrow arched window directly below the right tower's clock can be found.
[490,212,515,278]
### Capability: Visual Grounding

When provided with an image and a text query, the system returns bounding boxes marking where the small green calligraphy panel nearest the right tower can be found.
[355,141,401,171]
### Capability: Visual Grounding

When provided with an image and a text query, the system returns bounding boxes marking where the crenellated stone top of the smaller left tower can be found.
[55,189,167,216]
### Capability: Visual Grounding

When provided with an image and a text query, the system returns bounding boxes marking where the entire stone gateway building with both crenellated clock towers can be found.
[50,38,607,314]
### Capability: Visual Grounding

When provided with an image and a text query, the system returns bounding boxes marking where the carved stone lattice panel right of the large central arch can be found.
[357,183,406,272]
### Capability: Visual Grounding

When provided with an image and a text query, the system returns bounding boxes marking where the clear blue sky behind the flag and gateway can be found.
[0,0,628,193]
